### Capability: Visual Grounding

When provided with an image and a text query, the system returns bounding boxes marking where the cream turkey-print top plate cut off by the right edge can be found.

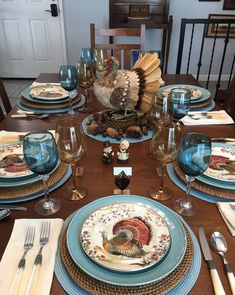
[203,144,235,182]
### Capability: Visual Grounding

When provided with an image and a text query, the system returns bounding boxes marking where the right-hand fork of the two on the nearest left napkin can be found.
[26,221,51,295]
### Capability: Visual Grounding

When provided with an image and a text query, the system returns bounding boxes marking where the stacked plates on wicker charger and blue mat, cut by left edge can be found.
[0,141,71,203]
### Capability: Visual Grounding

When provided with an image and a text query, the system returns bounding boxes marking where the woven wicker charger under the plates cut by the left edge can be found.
[0,162,67,200]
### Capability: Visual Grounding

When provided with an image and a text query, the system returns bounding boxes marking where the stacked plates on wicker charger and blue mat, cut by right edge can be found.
[167,143,235,202]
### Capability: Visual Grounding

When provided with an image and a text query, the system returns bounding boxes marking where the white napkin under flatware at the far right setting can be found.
[181,110,234,126]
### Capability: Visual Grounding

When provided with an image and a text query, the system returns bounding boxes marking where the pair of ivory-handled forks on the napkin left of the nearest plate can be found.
[9,221,50,295]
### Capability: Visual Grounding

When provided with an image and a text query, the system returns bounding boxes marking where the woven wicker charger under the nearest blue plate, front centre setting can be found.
[60,227,193,295]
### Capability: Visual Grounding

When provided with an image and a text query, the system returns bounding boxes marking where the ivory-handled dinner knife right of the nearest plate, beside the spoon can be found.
[199,227,226,295]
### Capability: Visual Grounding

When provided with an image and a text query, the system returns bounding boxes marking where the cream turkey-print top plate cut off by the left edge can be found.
[0,142,33,178]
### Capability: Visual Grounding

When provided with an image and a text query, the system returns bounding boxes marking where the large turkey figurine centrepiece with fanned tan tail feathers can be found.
[94,53,161,116]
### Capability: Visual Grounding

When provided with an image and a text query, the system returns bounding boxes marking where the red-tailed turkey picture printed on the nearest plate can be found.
[101,218,151,257]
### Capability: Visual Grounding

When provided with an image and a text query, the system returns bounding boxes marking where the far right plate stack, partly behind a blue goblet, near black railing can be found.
[157,84,215,112]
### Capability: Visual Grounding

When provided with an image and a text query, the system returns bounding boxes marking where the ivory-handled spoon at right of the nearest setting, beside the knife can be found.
[211,231,235,295]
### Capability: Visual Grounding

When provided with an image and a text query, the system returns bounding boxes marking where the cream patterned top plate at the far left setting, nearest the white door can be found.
[30,84,69,100]
